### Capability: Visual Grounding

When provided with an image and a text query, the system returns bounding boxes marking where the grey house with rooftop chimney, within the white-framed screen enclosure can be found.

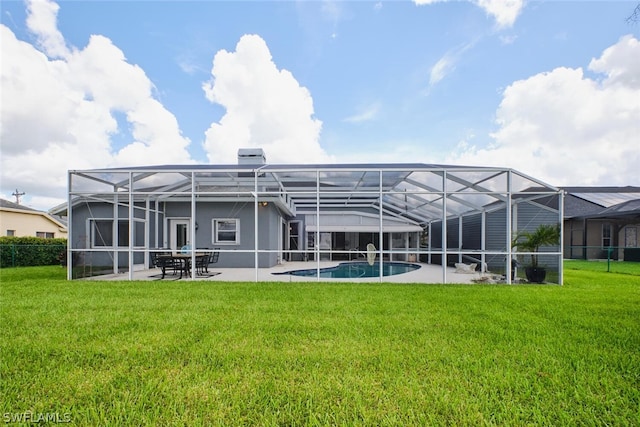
[55,149,563,280]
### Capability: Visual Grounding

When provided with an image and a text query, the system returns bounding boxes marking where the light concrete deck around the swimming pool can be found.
[90,261,496,283]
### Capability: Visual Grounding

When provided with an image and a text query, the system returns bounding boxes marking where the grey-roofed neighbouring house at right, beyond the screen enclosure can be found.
[563,186,640,261]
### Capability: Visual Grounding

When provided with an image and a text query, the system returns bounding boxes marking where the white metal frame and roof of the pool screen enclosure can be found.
[67,163,563,284]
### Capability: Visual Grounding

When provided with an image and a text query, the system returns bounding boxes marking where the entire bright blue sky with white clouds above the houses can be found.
[0,0,640,210]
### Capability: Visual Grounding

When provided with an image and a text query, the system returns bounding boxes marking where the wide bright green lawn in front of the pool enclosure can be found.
[0,267,640,426]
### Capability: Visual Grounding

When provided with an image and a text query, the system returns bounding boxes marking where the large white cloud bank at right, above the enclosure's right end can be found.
[449,36,640,189]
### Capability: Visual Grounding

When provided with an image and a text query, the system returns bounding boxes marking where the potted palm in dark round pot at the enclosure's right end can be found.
[512,224,560,283]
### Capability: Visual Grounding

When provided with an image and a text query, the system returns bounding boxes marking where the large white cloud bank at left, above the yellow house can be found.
[0,1,192,209]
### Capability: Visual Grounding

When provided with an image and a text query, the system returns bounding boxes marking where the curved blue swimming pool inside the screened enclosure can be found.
[273,261,420,279]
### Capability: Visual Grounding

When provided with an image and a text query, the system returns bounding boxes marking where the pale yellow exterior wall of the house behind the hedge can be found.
[0,209,67,238]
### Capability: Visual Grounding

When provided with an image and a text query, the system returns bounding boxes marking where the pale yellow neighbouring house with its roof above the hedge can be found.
[0,199,67,239]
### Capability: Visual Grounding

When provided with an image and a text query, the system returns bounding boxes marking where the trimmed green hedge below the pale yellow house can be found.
[0,236,67,267]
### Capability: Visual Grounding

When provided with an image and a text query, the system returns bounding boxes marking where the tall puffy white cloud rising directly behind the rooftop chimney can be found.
[203,35,332,163]
